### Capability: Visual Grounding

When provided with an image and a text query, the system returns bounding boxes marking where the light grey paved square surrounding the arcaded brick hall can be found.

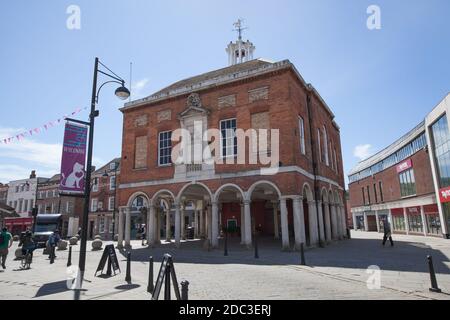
[0,231,450,300]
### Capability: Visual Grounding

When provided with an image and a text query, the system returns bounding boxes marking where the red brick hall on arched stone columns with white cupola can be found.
[118,35,346,249]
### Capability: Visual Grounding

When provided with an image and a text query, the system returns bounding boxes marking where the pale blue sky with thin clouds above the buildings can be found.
[0,0,450,182]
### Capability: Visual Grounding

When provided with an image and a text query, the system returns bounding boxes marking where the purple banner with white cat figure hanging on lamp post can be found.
[59,122,88,194]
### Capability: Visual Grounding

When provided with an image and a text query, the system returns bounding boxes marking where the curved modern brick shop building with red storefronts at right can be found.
[349,122,442,236]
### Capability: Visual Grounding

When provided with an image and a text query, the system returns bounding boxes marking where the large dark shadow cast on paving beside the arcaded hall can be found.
[113,237,450,274]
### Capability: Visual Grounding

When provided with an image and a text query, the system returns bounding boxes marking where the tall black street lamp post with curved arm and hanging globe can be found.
[77,58,130,295]
